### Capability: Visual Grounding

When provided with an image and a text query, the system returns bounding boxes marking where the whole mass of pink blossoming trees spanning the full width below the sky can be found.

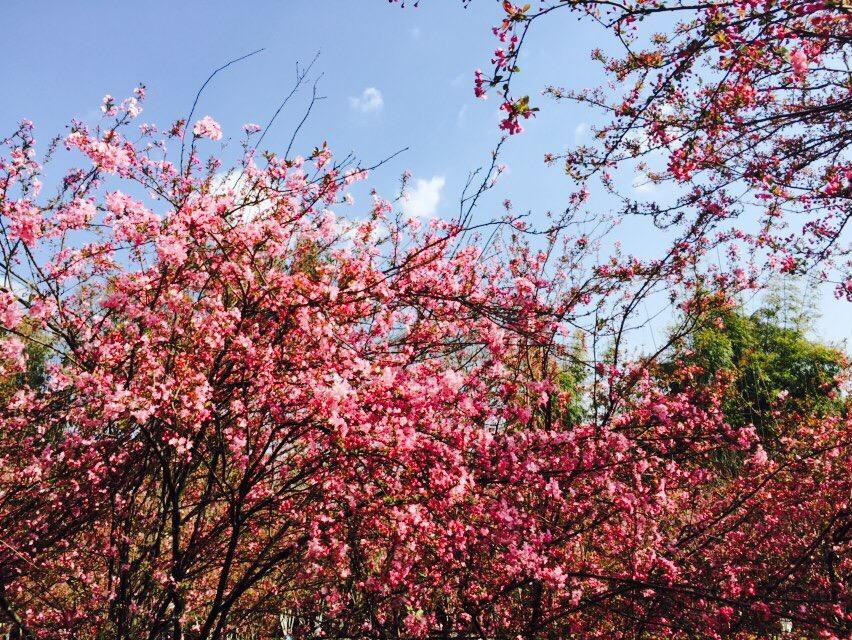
[0,88,852,640]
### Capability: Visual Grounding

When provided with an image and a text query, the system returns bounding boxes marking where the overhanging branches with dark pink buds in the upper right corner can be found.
[422,0,852,297]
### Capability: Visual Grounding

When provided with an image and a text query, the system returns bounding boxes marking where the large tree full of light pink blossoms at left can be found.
[0,88,572,638]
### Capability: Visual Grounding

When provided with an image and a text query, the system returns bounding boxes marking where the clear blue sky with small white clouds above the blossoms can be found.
[0,0,852,339]
